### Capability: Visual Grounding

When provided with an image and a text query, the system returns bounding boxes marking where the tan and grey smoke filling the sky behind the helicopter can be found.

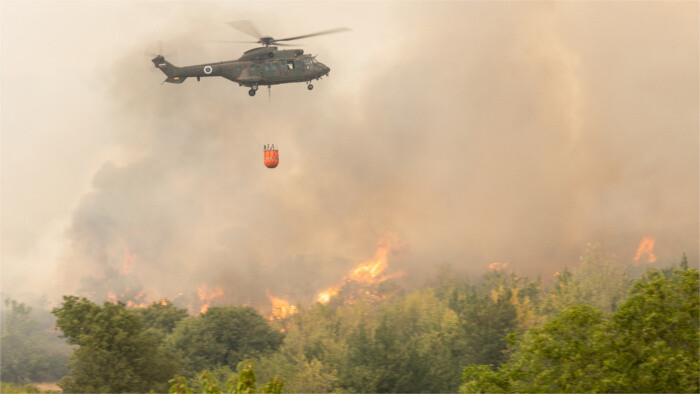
[0,2,699,307]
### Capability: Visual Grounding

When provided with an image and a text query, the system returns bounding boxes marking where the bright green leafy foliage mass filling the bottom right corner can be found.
[460,269,700,392]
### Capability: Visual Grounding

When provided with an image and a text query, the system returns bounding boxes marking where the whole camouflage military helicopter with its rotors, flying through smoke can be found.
[151,21,350,97]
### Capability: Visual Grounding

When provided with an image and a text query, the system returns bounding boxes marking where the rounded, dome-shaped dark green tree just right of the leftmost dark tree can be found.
[166,306,284,377]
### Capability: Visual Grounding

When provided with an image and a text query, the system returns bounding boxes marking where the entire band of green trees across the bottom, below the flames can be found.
[8,247,700,394]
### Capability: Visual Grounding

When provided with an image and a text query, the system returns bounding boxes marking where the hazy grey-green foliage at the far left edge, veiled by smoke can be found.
[0,298,71,384]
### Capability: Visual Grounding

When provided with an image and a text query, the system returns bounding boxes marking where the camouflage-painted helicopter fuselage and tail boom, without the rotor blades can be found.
[152,47,330,87]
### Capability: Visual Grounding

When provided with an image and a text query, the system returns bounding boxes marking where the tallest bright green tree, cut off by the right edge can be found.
[601,269,700,393]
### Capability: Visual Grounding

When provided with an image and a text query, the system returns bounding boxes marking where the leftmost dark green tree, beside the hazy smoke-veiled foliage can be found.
[52,296,177,393]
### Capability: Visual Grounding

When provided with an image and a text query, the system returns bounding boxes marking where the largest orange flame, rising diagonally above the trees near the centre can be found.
[316,238,403,305]
